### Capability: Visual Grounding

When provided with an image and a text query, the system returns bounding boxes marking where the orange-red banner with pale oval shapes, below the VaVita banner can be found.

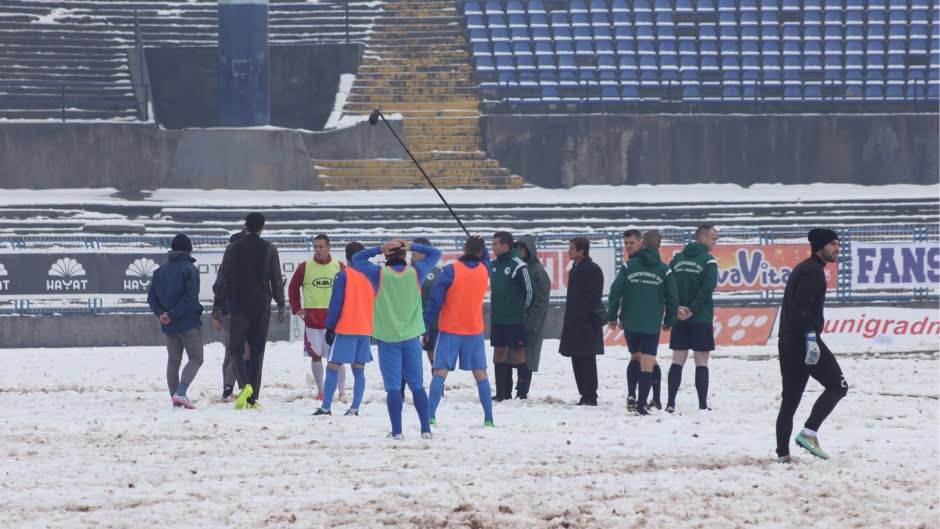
[604,307,777,347]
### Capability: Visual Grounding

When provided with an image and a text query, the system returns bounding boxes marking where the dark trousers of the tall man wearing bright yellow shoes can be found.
[225,310,271,404]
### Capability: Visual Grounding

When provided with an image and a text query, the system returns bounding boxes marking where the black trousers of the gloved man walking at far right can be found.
[777,335,849,456]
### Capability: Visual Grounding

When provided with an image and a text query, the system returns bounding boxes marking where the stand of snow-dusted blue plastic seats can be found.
[463,0,940,102]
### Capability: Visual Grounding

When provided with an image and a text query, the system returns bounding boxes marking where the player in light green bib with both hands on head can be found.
[352,240,441,440]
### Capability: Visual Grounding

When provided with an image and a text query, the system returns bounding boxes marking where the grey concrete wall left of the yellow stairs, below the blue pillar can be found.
[0,120,404,190]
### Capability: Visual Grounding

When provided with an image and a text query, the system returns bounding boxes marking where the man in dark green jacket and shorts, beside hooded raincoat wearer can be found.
[490,231,534,402]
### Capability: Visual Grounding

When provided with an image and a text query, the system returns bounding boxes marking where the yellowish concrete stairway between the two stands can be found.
[314,0,522,189]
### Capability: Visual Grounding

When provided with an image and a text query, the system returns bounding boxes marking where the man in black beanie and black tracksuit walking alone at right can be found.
[777,228,849,463]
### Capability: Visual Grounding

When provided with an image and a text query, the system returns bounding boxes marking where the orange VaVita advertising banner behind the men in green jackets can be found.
[661,244,836,292]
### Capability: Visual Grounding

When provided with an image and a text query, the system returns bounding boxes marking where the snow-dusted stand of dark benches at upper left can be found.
[0,0,378,121]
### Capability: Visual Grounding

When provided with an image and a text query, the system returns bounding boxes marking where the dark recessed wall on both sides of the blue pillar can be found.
[146,44,363,130]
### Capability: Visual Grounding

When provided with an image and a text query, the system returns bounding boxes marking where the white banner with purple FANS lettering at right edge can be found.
[852,242,940,290]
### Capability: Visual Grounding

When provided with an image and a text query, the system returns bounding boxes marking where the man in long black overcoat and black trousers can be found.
[558,237,604,406]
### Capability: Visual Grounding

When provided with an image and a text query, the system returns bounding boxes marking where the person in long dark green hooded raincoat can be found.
[513,235,552,399]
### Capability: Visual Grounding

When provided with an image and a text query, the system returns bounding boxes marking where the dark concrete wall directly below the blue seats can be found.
[482,114,940,187]
